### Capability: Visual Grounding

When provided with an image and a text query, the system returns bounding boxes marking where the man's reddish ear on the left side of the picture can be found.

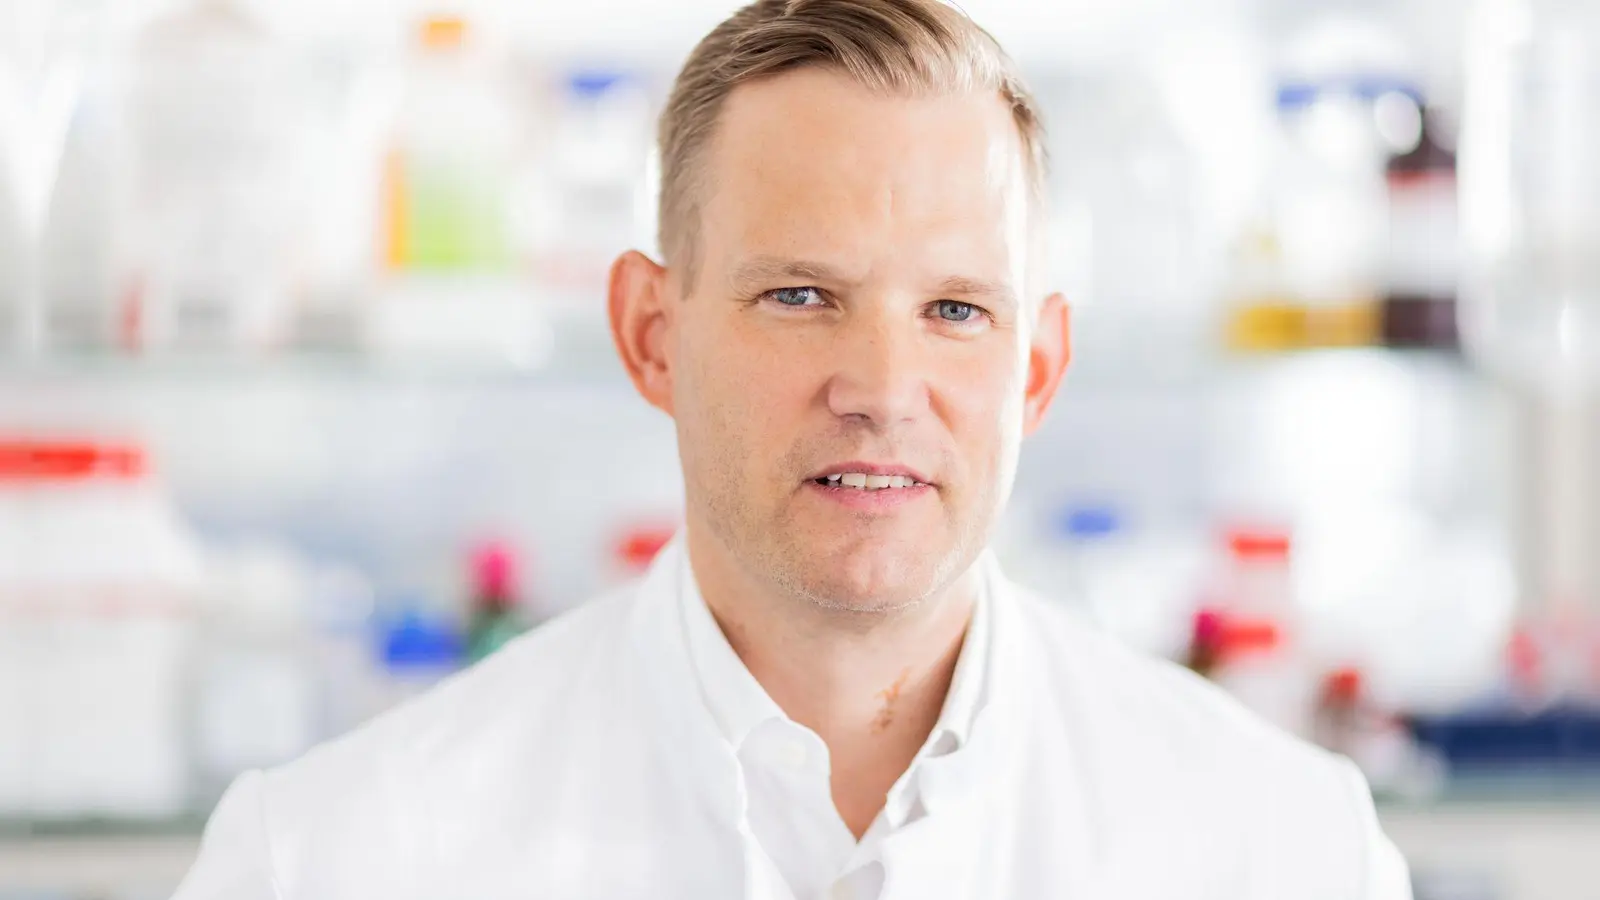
[608,250,675,416]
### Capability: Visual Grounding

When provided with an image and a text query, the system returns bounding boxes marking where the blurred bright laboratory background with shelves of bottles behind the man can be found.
[0,0,1600,900]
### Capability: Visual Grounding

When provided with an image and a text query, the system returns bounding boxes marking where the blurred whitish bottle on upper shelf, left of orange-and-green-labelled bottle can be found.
[118,0,309,351]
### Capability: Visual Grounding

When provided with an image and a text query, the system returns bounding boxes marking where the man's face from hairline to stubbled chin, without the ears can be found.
[649,69,1054,612]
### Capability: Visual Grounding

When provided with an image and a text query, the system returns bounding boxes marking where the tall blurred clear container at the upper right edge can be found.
[1459,0,1600,389]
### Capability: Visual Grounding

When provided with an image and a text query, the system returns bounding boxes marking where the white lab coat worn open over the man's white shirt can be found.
[176,546,1411,900]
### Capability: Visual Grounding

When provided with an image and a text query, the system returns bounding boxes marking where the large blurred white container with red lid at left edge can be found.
[0,442,202,818]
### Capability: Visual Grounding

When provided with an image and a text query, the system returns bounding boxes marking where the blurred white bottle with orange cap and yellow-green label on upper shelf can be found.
[366,16,547,364]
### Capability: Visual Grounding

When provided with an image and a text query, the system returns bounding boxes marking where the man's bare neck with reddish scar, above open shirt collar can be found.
[688,528,978,839]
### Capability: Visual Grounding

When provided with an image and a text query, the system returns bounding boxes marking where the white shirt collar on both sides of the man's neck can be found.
[678,552,990,756]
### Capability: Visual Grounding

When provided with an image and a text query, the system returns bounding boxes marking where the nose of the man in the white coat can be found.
[826,303,931,431]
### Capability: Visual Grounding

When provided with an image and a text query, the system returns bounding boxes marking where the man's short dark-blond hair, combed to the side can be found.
[658,0,1046,280]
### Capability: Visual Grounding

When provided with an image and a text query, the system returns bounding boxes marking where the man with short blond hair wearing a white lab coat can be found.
[178,0,1410,900]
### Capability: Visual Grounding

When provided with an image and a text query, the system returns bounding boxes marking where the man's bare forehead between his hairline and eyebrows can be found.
[701,67,1027,280]
